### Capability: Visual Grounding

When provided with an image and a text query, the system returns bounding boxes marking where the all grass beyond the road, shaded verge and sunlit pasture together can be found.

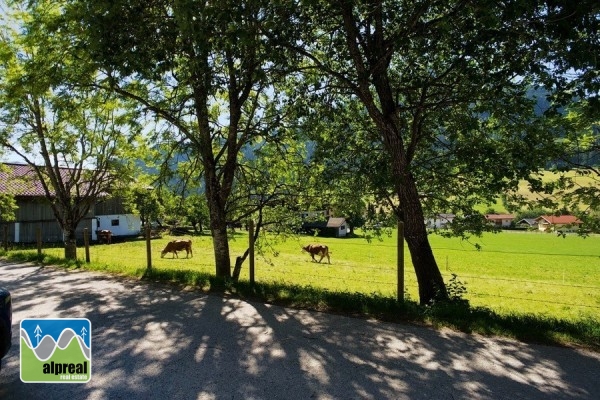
[4,228,600,348]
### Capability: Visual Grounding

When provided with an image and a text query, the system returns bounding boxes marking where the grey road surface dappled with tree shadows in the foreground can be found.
[0,262,600,400]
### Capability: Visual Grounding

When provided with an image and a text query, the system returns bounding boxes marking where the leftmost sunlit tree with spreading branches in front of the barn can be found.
[0,2,142,259]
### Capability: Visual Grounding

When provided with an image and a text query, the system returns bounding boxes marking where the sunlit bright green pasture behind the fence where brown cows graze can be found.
[25,231,600,321]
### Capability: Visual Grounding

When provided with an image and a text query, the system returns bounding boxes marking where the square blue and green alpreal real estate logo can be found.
[21,318,92,383]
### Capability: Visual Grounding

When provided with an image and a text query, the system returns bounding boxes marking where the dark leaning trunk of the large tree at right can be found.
[338,1,448,304]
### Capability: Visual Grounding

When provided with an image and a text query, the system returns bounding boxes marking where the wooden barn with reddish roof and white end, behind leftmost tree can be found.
[0,164,141,243]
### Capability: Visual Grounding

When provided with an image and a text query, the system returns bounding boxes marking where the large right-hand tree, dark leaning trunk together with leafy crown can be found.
[272,0,596,303]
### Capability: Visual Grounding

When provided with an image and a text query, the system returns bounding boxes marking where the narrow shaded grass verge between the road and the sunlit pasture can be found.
[0,251,600,351]
